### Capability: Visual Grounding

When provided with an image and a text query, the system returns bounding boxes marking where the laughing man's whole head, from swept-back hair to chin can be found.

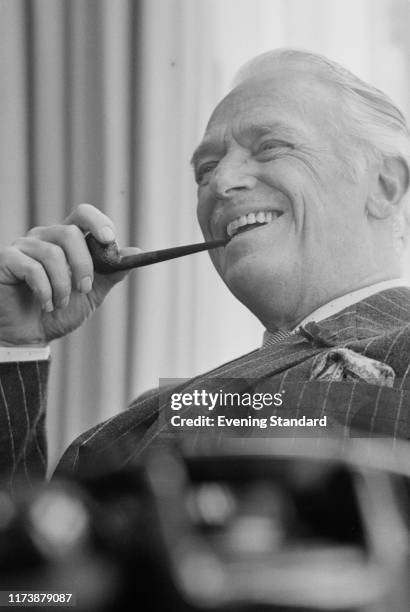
[193,52,409,330]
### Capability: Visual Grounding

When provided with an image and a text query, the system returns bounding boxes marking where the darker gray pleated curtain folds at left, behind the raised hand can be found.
[0,0,140,463]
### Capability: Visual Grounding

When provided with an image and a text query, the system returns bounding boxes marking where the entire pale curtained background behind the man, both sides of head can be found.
[0,0,410,463]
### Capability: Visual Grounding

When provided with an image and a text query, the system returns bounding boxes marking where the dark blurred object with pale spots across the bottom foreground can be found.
[0,439,410,612]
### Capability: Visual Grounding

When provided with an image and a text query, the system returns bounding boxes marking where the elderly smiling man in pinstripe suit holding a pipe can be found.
[0,50,410,486]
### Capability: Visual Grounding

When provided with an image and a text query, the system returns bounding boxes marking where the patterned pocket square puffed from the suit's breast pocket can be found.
[310,348,395,387]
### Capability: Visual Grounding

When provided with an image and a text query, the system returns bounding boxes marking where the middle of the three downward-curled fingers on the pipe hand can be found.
[14,238,71,308]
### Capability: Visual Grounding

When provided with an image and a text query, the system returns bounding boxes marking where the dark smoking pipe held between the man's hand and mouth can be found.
[85,234,229,274]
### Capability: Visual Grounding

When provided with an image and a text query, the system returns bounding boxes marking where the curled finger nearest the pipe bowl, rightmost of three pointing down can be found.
[25,225,94,293]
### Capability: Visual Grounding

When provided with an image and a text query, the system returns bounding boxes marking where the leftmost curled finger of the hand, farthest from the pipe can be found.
[1,246,53,312]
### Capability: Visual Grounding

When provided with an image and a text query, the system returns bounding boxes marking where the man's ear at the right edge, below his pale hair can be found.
[366,157,410,219]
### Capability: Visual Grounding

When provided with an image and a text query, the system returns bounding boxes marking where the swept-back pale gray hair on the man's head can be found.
[233,48,410,240]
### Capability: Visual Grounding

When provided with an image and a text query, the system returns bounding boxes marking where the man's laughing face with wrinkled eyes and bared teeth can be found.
[193,70,369,324]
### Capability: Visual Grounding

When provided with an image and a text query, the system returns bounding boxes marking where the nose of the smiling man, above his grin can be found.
[210,155,256,198]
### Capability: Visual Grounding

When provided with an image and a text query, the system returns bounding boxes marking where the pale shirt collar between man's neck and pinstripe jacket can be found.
[262,278,406,348]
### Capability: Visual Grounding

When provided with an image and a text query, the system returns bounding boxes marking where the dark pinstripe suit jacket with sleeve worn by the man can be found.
[0,287,410,482]
